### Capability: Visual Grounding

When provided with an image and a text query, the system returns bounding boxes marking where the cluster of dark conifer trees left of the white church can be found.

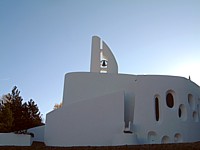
[0,86,43,132]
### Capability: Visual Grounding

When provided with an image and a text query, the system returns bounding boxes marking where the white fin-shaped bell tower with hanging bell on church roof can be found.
[90,36,118,73]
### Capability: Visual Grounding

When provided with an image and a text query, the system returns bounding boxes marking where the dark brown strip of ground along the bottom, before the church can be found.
[0,142,200,150]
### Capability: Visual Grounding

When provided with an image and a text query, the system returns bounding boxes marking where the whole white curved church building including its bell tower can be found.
[44,36,200,146]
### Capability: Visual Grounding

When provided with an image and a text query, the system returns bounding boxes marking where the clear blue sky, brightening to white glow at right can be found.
[0,0,200,118]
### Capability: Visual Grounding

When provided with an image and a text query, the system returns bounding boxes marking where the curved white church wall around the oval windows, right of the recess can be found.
[134,76,200,143]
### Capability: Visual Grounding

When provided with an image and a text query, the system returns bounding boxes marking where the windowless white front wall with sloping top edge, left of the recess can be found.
[45,91,124,146]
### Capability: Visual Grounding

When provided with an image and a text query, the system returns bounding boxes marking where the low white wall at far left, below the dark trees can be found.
[0,133,32,146]
